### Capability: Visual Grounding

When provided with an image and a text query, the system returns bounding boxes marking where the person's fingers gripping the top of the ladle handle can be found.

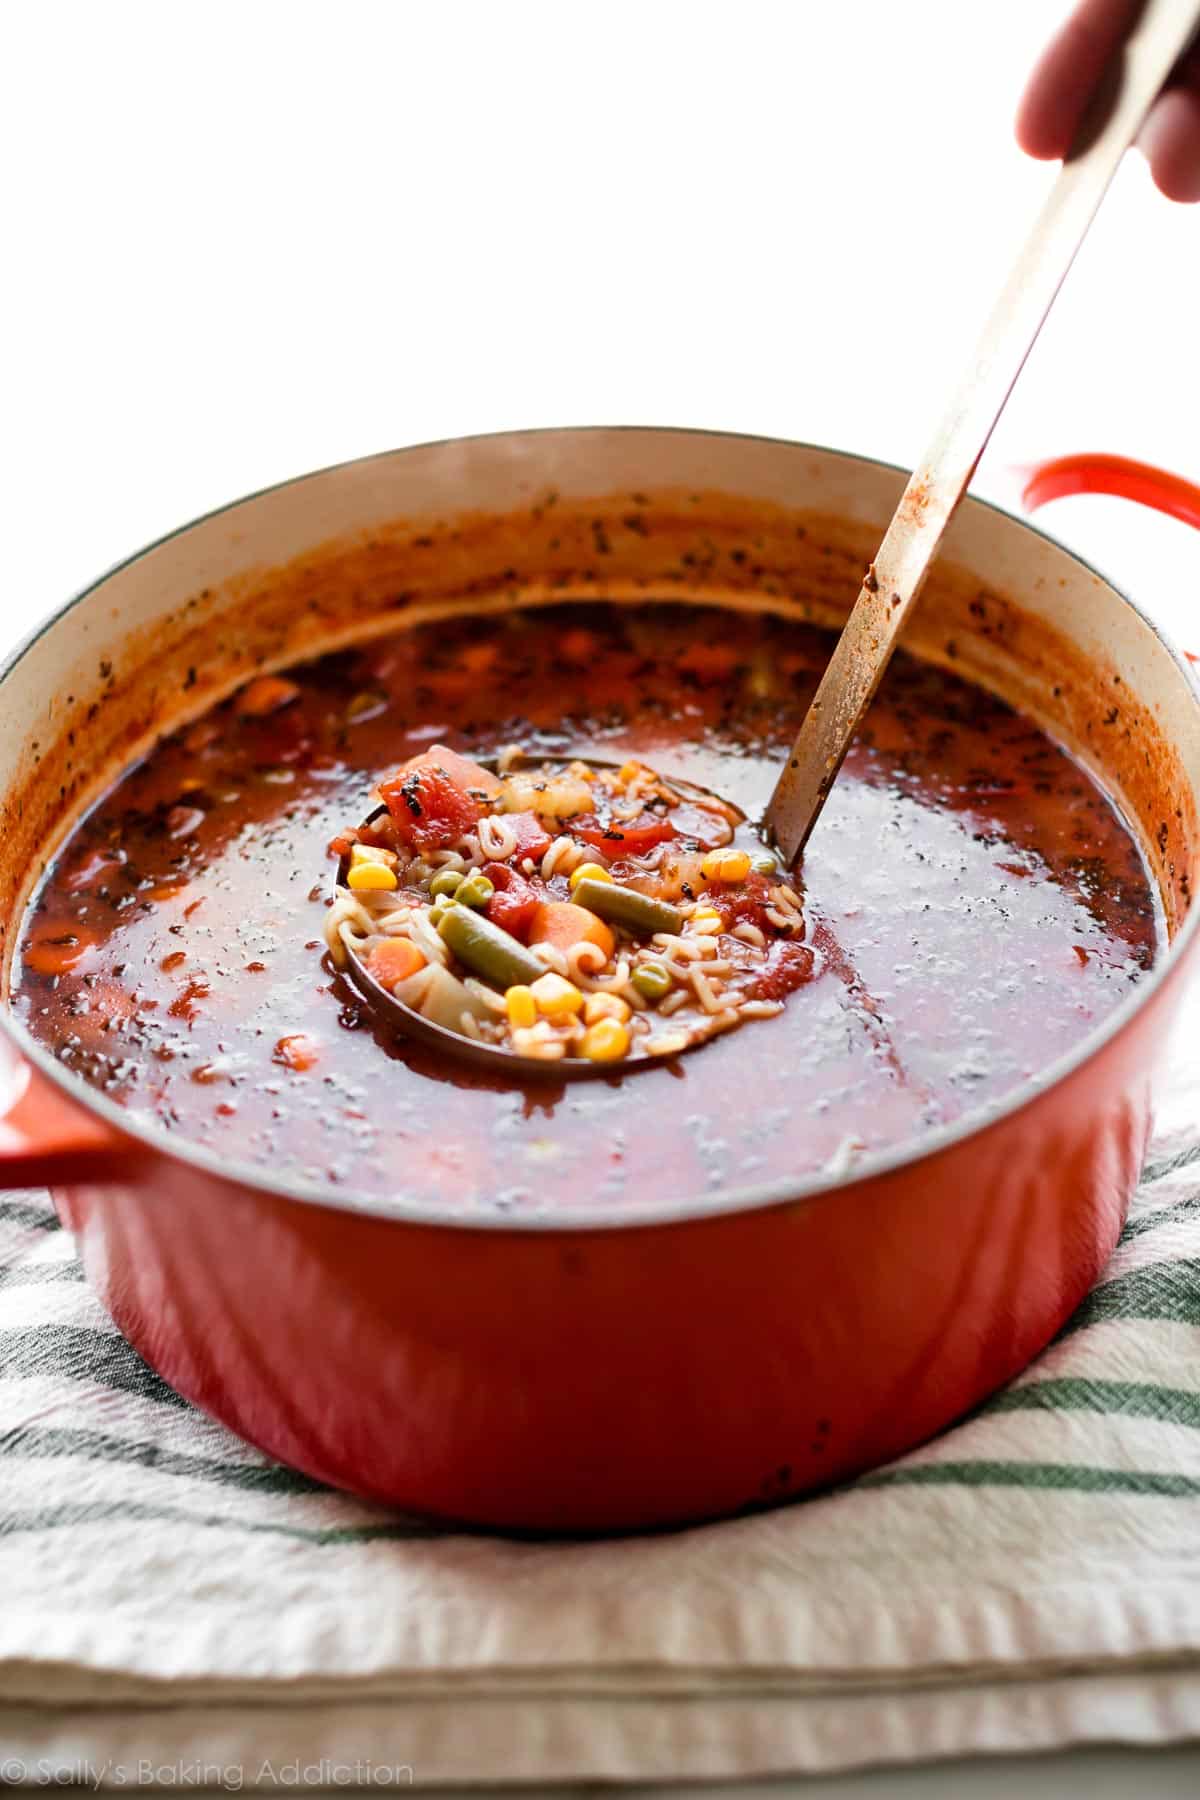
[1016,0,1200,202]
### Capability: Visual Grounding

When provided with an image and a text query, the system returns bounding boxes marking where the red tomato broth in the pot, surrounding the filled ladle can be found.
[14,603,1164,1210]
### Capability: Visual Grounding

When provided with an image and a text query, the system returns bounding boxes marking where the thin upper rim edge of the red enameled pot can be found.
[0,425,1200,1233]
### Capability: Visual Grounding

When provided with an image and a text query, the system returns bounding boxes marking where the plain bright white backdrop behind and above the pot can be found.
[0,0,1200,1795]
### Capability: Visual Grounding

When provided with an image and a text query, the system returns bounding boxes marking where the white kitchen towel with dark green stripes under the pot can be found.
[0,1042,1200,1787]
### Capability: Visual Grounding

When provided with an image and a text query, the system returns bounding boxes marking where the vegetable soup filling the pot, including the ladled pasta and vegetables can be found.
[14,601,1164,1213]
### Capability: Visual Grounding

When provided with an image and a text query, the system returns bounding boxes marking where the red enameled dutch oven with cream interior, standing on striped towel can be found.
[0,428,1200,1532]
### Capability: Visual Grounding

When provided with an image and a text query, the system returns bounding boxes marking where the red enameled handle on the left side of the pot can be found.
[0,1039,148,1190]
